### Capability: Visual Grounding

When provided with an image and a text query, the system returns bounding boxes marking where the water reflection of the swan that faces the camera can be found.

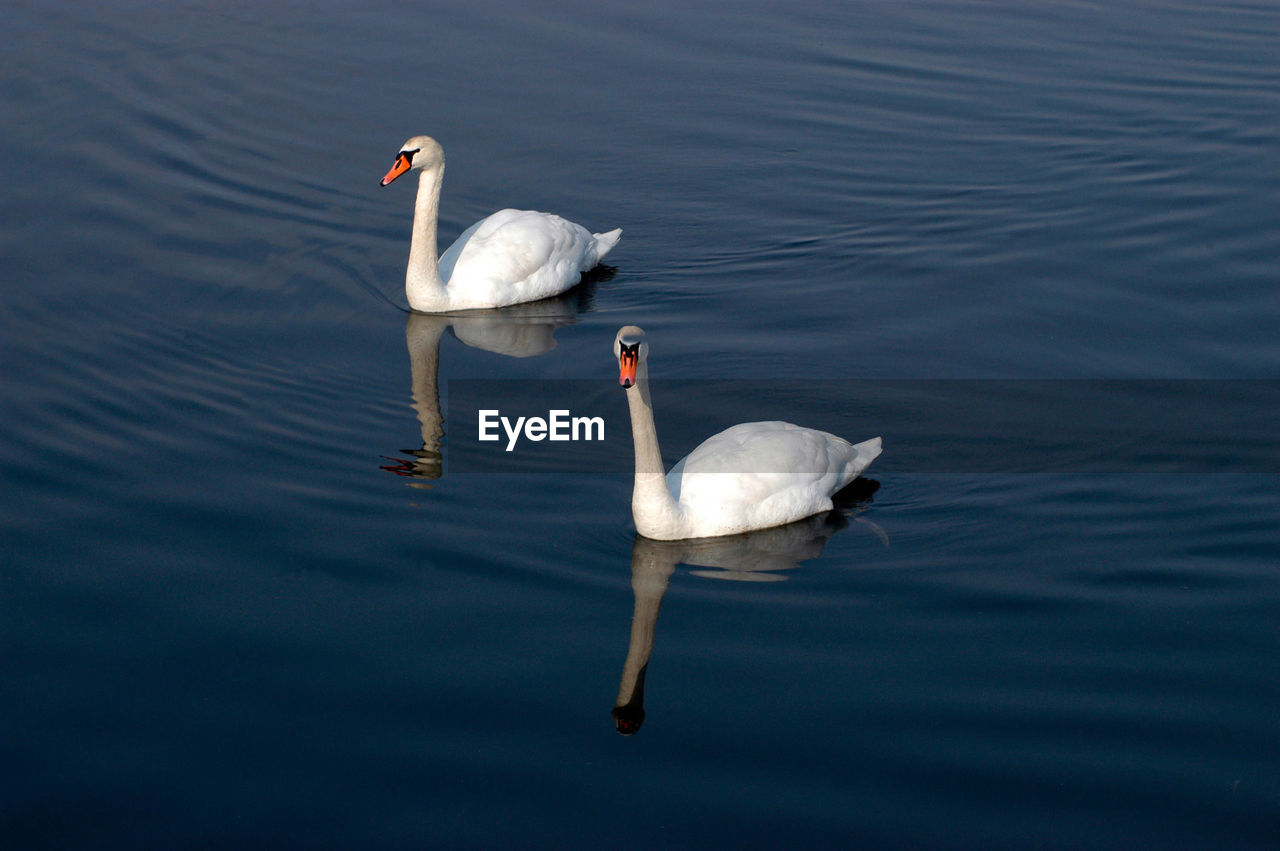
[613,479,888,736]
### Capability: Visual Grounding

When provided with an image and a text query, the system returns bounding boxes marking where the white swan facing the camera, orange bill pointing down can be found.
[613,325,881,541]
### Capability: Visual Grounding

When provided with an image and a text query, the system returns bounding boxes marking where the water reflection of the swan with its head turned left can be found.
[383,281,599,488]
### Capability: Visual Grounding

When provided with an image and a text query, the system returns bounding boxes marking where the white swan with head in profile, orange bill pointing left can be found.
[381,136,622,314]
